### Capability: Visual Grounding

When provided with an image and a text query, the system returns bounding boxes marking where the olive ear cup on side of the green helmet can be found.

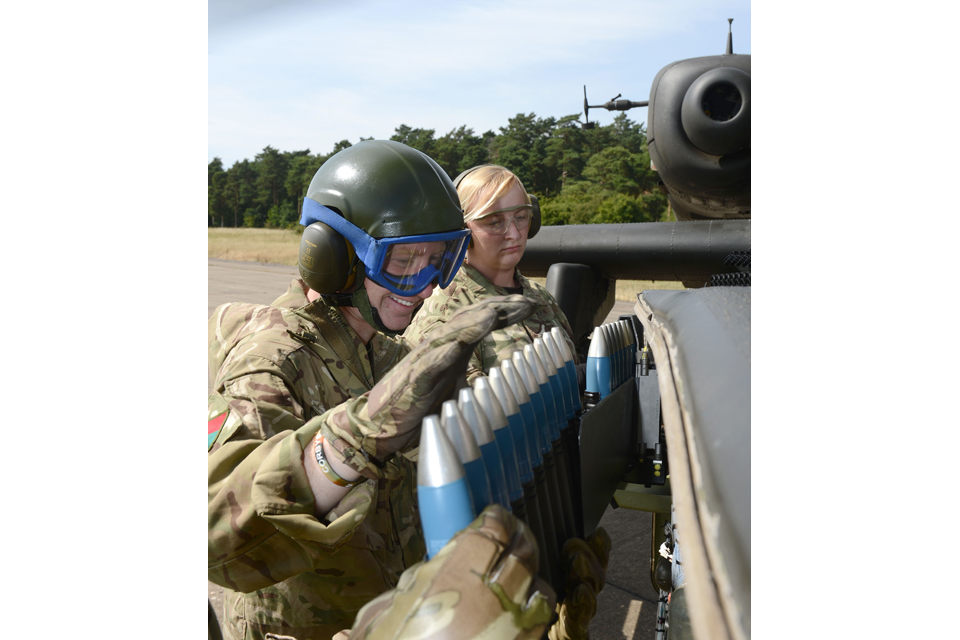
[297,222,356,293]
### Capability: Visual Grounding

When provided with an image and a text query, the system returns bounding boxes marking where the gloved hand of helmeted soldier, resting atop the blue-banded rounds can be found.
[321,295,534,478]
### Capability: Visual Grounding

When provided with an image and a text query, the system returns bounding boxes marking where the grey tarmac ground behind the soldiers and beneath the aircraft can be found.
[207,258,657,640]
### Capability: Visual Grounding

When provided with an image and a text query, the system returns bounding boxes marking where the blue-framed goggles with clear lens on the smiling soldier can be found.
[300,198,470,296]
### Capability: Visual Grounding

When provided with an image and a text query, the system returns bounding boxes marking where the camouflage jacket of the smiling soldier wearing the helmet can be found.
[208,280,425,640]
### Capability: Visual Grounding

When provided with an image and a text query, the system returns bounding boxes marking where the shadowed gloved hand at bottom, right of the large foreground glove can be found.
[549,527,611,640]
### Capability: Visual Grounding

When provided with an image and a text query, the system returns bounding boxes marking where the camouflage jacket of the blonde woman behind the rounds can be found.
[403,263,576,385]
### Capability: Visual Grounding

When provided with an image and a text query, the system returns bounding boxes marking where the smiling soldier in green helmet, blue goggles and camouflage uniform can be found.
[208,141,531,640]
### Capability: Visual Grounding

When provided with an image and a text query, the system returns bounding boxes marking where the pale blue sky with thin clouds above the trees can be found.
[208,0,751,167]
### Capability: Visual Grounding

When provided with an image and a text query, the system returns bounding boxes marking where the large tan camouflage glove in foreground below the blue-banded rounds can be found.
[338,504,556,640]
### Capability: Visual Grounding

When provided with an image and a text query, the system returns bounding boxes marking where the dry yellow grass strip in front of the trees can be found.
[207,228,684,301]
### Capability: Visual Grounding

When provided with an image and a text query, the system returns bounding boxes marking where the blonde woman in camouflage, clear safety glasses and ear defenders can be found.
[404,165,577,384]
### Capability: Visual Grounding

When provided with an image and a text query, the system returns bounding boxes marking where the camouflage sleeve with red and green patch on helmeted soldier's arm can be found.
[207,373,374,592]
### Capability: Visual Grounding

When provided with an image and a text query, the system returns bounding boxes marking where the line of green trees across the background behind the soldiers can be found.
[207,113,670,229]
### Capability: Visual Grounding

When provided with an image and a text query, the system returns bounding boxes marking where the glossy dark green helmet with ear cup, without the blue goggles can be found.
[298,140,466,294]
